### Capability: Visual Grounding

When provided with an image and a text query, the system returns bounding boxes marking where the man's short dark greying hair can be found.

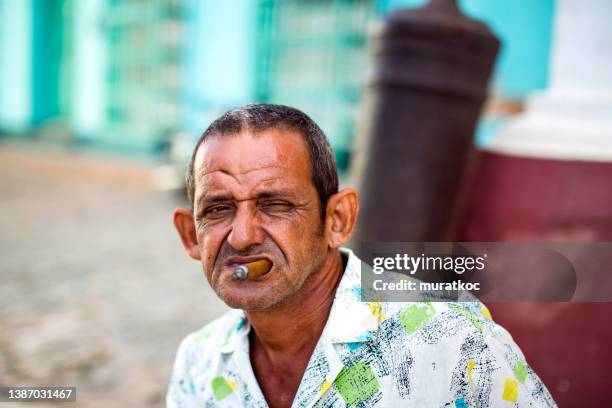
[186,103,338,219]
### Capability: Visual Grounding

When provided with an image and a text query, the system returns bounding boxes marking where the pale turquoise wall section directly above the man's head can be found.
[183,0,256,136]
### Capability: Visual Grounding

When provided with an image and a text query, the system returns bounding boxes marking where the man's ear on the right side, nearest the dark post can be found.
[325,188,359,248]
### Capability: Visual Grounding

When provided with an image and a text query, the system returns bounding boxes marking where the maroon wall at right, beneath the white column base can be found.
[457,152,612,407]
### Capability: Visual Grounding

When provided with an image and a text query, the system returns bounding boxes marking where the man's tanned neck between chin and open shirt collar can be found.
[246,250,343,357]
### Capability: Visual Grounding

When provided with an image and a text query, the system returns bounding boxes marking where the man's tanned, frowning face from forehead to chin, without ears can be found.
[193,128,327,310]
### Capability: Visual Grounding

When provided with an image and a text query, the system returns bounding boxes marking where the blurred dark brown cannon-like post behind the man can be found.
[351,0,499,250]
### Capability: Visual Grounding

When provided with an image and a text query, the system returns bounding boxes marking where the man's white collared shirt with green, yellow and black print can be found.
[166,249,556,408]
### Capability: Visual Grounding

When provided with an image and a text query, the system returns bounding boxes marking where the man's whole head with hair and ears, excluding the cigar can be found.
[174,105,358,310]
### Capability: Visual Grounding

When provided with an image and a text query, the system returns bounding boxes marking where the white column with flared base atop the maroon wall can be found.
[486,0,612,161]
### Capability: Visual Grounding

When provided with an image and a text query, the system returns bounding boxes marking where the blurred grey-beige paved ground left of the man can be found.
[0,145,225,407]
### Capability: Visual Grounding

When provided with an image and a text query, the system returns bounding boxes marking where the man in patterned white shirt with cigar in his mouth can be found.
[167,104,554,407]
